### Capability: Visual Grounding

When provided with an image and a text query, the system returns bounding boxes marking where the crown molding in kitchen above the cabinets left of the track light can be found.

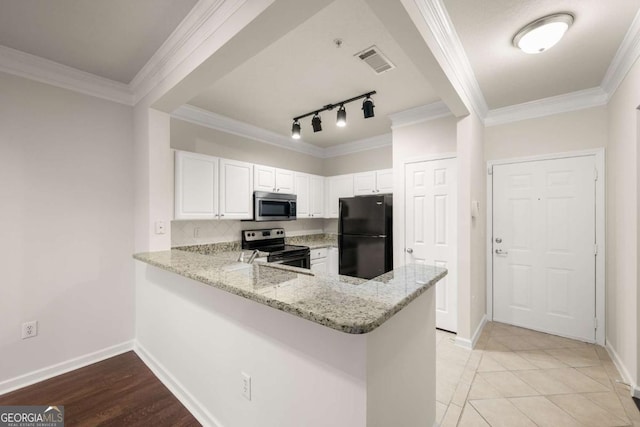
[171,105,324,157]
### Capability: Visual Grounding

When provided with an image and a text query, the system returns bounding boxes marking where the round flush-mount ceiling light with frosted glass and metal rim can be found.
[513,13,573,54]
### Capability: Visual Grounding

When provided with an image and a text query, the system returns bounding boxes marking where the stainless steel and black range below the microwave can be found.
[242,228,311,268]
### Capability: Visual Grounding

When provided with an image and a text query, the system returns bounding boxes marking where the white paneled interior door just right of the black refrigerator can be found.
[405,159,458,332]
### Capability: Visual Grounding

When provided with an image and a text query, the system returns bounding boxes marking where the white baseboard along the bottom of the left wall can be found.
[0,340,134,395]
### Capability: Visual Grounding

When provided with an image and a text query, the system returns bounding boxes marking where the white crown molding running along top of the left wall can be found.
[0,45,133,105]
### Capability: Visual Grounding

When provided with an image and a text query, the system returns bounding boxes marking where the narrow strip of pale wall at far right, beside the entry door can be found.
[606,58,640,387]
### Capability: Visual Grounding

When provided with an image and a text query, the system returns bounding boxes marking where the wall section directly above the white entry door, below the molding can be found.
[484,107,608,161]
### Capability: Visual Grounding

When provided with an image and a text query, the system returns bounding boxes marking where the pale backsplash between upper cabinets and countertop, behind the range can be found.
[171,219,328,247]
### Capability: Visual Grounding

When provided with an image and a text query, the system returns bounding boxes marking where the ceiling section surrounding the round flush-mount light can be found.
[443,0,640,109]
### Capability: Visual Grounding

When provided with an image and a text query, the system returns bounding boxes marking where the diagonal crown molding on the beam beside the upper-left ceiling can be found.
[129,0,247,103]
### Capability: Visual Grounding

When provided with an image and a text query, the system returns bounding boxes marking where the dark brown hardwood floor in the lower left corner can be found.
[0,351,200,427]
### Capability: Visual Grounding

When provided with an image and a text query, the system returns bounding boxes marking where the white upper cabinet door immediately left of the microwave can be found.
[220,159,253,219]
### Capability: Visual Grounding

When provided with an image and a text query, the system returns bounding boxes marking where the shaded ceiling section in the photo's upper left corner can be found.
[0,0,197,83]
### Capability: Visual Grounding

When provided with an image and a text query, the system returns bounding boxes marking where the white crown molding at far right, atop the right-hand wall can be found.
[600,11,640,98]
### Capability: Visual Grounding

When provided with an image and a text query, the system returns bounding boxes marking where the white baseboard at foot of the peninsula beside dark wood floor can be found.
[134,341,223,427]
